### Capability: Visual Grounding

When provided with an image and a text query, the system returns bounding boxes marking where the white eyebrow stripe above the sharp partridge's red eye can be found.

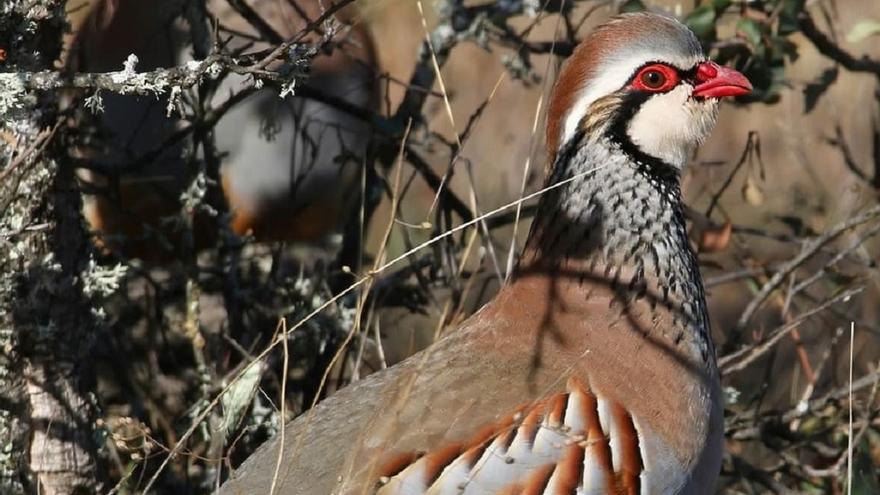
[556,50,704,149]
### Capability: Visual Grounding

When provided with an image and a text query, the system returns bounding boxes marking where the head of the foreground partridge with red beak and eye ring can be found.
[547,14,752,168]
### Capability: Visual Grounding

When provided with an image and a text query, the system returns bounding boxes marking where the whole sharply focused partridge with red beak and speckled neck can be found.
[222,14,750,495]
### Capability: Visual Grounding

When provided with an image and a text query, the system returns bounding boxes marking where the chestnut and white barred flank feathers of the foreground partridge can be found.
[377,378,643,495]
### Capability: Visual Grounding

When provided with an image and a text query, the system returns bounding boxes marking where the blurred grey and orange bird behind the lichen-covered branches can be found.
[67,0,379,261]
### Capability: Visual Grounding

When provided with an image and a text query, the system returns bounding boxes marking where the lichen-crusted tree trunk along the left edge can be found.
[0,0,101,494]
